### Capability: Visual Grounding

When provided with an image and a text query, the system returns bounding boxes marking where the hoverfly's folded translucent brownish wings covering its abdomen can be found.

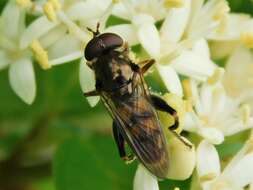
[102,85,169,178]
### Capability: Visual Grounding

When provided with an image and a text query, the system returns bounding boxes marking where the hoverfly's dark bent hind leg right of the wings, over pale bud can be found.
[151,95,192,148]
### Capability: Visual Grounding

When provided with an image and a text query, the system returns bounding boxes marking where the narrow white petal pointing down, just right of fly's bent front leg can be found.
[156,64,183,97]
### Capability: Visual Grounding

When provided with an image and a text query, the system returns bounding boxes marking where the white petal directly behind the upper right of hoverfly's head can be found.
[105,24,139,46]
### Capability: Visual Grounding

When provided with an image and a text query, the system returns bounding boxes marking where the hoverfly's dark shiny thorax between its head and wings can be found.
[93,51,133,93]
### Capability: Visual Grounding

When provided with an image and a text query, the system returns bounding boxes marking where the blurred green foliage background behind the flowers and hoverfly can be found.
[0,0,253,190]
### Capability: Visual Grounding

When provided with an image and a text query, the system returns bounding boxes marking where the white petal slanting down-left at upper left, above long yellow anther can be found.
[20,16,59,49]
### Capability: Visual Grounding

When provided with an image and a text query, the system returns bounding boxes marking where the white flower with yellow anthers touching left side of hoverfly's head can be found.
[20,0,114,106]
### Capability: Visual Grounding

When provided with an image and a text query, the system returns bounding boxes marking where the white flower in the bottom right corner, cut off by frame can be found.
[197,140,253,190]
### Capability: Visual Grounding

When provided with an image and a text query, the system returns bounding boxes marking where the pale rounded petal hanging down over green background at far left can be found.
[9,59,36,104]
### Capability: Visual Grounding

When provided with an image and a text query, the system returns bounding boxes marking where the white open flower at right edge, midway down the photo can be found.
[184,68,253,144]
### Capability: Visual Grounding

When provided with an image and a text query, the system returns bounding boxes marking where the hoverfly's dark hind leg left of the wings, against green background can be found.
[112,121,135,164]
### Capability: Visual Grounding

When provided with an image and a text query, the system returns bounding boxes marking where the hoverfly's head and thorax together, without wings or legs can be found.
[84,26,133,93]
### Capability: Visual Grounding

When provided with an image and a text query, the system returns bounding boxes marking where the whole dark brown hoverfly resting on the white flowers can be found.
[84,25,191,178]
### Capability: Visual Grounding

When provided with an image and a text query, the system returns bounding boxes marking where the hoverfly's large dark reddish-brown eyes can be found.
[84,33,123,61]
